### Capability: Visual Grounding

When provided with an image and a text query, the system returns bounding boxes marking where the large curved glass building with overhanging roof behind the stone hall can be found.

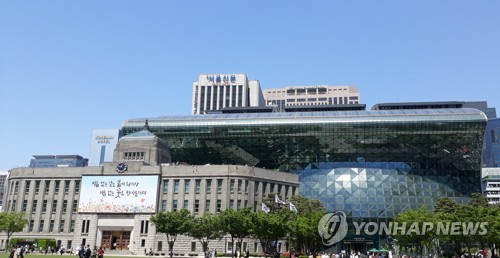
[123,109,487,215]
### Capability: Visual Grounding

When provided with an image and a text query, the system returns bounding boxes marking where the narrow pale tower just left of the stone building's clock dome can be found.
[89,129,121,166]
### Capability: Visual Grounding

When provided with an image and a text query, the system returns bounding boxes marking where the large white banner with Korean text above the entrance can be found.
[78,176,158,213]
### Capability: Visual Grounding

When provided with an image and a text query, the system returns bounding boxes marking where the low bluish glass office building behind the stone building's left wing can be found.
[30,155,89,168]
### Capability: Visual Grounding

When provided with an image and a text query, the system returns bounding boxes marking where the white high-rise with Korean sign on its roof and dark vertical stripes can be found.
[192,74,265,115]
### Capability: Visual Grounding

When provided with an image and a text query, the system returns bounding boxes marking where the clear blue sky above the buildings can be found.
[0,0,500,170]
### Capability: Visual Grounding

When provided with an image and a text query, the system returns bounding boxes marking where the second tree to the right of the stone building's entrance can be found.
[187,213,224,252]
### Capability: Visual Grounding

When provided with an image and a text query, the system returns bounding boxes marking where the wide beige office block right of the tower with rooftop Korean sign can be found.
[263,85,360,112]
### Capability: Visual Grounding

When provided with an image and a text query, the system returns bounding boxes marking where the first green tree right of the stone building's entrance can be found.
[151,209,193,257]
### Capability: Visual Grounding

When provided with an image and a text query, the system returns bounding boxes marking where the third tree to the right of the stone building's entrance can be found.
[219,208,253,254]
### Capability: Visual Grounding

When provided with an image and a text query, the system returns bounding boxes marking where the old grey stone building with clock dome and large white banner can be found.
[0,125,299,254]
